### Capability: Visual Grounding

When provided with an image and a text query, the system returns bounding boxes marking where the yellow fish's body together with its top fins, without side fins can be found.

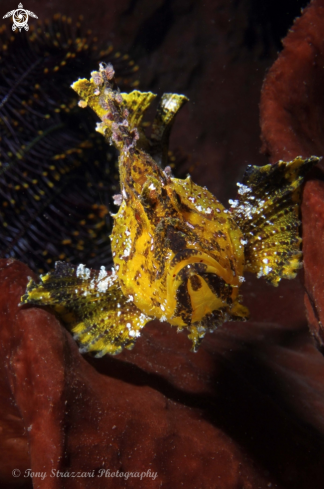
[67,71,248,348]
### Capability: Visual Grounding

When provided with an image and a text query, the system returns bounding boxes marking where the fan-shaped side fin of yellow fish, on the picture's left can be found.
[22,262,151,357]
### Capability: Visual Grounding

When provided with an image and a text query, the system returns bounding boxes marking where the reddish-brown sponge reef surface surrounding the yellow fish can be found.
[0,1,324,489]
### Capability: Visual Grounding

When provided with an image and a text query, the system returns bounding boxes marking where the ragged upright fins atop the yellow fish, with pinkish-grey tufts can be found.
[72,63,188,159]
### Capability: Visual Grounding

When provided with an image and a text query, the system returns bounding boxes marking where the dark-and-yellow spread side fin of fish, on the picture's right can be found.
[230,157,319,286]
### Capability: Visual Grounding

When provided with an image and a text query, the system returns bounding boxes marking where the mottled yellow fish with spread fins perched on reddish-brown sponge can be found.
[22,63,318,356]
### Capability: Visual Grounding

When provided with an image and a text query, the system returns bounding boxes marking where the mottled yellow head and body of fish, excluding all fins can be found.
[111,152,244,327]
